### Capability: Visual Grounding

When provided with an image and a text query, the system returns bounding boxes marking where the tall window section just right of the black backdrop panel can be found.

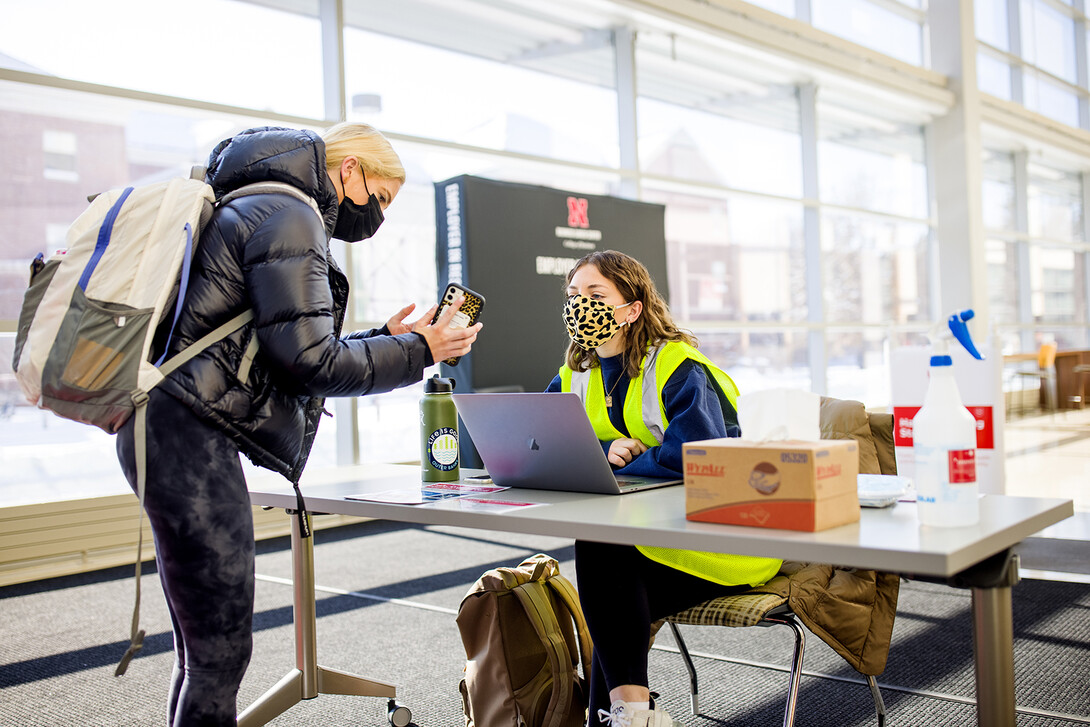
[637,38,810,390]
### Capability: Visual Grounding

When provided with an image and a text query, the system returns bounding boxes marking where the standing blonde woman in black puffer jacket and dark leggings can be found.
[118,124,480,727]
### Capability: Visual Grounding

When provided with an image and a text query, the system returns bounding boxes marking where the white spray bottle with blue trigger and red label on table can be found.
[912,310,984,528]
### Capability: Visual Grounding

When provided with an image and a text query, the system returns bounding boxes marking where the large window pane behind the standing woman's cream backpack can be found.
[0,81,337,505]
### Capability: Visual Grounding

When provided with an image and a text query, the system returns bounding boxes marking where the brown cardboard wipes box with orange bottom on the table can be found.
[682,438,859,531]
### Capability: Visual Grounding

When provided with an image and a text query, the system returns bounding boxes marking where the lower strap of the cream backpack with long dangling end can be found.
[113,310,257,677]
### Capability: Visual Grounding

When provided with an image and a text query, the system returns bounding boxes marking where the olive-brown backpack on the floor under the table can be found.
[456,554,592,727]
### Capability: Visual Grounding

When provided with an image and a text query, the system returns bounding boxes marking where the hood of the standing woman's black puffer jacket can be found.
[207,126,338,237]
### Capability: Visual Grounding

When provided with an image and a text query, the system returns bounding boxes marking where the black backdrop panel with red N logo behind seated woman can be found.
[435,175,668,391]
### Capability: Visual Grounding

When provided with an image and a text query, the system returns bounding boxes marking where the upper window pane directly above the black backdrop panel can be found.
[344,27,619,167]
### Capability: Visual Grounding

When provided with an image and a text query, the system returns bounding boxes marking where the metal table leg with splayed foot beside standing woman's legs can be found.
[239,513,396,727]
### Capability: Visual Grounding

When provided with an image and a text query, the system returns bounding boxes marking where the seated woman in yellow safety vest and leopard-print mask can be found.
[548,251,780,727]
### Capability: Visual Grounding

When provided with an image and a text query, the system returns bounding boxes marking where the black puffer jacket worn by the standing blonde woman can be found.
[159,128,431,482]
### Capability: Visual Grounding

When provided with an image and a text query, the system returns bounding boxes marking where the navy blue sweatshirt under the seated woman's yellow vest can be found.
[546,355,741,477]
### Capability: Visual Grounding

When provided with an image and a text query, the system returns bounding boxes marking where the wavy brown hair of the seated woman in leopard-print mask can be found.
[565,250,697,378]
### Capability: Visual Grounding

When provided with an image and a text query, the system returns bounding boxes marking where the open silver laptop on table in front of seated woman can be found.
[453,392,683,495]
